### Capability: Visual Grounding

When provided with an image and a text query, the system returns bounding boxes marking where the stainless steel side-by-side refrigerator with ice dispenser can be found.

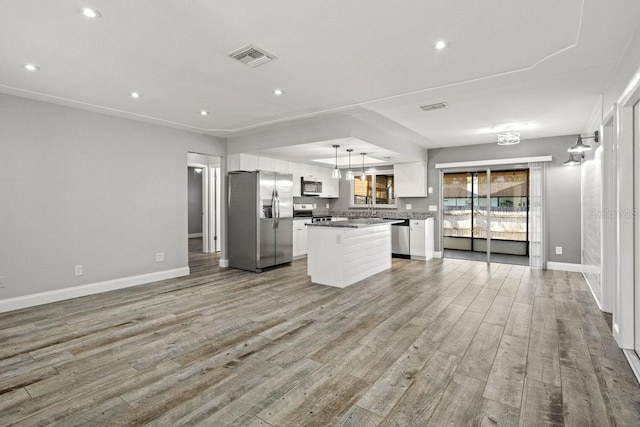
[227,170,293,272]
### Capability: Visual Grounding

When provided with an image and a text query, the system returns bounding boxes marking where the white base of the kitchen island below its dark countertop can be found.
[307,224,391,288]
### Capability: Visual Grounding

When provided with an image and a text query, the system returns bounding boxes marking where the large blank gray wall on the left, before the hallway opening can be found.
[0,94,225,299]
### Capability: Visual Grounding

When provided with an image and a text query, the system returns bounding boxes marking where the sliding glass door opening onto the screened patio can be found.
[442,168,530,265]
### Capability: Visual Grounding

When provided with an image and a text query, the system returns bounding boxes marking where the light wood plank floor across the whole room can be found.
[0,242,640,427]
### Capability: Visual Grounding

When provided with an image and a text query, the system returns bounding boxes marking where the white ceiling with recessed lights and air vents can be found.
[0,0,640,156]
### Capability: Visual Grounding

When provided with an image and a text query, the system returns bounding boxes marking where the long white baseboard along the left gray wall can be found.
[0,267,189,313]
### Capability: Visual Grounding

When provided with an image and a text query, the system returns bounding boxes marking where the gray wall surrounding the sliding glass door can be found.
[427,135,581,264]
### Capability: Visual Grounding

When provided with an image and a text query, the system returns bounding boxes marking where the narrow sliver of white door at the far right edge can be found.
[632,102,640,356]
